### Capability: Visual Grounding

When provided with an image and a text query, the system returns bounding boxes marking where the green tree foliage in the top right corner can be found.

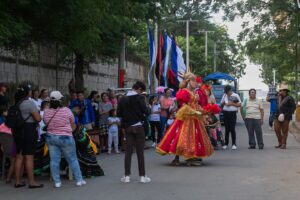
[232,0,300,85]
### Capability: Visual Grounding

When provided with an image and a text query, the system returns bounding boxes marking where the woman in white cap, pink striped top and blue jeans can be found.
[43,91,86,188]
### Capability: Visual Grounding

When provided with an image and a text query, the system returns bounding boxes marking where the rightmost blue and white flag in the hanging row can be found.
[172,38,187,82]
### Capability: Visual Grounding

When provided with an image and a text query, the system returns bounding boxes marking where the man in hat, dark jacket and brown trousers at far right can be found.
[274,84,296,149]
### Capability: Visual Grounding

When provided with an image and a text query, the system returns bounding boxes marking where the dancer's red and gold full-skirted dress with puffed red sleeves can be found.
[156,89,214,159]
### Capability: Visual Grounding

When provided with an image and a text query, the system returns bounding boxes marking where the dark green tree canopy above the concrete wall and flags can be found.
[0,0,244,89]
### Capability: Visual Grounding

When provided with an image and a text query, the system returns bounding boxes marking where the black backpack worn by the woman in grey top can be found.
[5,101,31,131]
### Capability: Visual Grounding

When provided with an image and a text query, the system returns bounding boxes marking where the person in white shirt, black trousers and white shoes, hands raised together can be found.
[221,85,241,150]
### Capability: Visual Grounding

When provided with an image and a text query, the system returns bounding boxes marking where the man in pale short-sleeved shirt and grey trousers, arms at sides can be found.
[241,89,264,149]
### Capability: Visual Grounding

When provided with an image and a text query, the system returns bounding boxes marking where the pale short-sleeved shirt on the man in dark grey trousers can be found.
[245,99,263,119]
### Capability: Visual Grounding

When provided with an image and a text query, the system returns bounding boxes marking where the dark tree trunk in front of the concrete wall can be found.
[75,53,84,91]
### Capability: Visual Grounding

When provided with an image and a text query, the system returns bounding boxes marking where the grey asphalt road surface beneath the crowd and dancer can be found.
[0,109,300,200]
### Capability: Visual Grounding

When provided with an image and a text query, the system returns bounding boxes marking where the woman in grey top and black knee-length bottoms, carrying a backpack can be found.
[13,85,43,189]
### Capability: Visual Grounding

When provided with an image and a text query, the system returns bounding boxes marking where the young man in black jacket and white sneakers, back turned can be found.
[118,81,151,183]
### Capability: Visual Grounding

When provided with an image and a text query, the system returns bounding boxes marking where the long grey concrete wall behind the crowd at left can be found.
[0,51,148,94]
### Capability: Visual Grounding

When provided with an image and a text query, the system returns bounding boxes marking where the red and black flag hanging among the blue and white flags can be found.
[155,33,166,86]
